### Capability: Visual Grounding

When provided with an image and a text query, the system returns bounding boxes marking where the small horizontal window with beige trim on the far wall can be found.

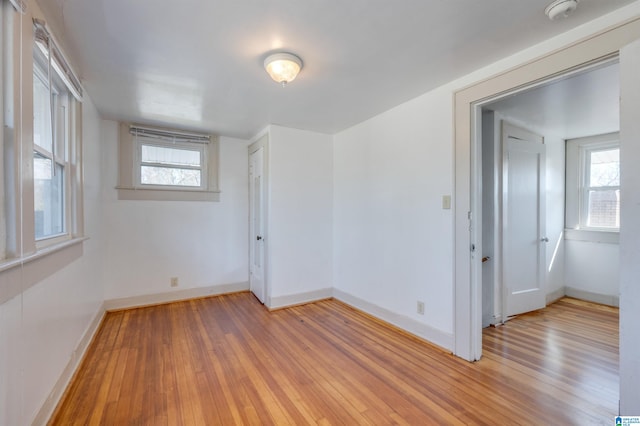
[118,123,219,201]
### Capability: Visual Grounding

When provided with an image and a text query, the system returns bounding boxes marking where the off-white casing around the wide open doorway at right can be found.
[453,17,640,361]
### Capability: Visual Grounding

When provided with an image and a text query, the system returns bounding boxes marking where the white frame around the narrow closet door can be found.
[247,132,271,307]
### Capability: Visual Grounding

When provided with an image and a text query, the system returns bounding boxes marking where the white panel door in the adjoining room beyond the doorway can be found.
[502,122,547,318]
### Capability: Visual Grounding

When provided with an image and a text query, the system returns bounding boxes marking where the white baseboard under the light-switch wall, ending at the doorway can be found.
[333,288,453,351]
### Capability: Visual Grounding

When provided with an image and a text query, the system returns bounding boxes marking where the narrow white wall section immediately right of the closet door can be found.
[267,125,333,308]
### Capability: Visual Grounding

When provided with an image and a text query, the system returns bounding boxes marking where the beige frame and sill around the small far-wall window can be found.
[116,123,220,201]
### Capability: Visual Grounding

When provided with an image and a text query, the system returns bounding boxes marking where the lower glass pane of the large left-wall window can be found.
[33,152,65,239]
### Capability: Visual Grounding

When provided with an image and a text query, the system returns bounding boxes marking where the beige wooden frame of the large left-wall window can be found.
[0,7,86,271]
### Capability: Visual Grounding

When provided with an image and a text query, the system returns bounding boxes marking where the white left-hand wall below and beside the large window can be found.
[0,95,104,425]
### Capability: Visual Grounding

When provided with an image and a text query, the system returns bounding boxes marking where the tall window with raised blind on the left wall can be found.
[32,19,83,251]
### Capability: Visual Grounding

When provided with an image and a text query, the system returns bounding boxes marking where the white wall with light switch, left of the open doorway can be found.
[333,87,453,346]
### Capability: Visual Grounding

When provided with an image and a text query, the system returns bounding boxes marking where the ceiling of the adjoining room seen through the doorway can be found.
[483,61,620,139]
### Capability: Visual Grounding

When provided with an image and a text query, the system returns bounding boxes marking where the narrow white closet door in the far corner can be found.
[249,148,266,303]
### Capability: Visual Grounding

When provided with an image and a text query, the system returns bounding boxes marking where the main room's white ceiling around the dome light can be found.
[39,0,634,138]
